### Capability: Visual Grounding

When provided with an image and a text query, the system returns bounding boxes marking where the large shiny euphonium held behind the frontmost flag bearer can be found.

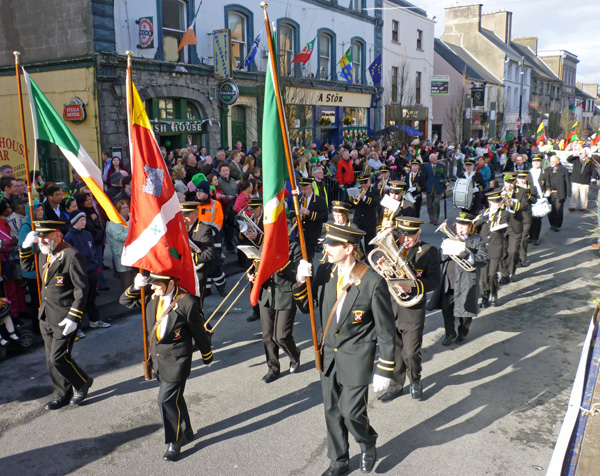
[367,228,424,307]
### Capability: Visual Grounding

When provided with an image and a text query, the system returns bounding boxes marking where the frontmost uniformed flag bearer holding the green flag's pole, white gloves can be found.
[294,224,394,476]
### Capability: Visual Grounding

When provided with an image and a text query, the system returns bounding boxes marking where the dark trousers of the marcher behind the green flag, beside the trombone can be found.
[260,305,300,373]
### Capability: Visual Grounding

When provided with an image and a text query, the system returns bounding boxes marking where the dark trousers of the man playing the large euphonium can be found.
[389,316,425,393]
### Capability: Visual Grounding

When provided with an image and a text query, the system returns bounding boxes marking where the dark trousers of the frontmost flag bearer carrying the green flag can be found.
[321,363,377,467]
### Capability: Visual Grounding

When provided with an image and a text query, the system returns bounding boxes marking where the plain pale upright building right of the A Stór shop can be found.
[382,0,435,139]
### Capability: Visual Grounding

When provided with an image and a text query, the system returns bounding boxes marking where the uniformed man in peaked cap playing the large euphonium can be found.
[379,217,442,403]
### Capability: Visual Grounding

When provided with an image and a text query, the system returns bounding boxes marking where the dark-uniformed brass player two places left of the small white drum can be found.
[500,172,529,284]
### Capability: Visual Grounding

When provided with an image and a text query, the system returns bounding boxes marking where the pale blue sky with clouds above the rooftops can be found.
[408,0,600,83]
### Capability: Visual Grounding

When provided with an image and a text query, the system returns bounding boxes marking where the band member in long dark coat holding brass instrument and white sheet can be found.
[427,212,489,345]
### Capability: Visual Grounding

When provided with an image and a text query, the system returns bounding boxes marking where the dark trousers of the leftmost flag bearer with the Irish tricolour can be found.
[40,320,90,398]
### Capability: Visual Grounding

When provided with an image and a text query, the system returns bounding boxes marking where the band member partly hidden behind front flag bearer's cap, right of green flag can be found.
[298,177,329,262]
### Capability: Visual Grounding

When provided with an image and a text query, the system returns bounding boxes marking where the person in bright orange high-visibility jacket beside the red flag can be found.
[196,180,226,296]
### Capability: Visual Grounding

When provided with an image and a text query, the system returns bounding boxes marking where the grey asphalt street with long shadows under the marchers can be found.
[0,205,598,476]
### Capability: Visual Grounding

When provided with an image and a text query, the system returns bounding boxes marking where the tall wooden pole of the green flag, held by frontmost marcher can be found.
[260,2,323,371]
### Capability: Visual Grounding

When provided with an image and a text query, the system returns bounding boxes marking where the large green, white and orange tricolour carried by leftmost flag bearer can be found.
[23,69,126,226]
